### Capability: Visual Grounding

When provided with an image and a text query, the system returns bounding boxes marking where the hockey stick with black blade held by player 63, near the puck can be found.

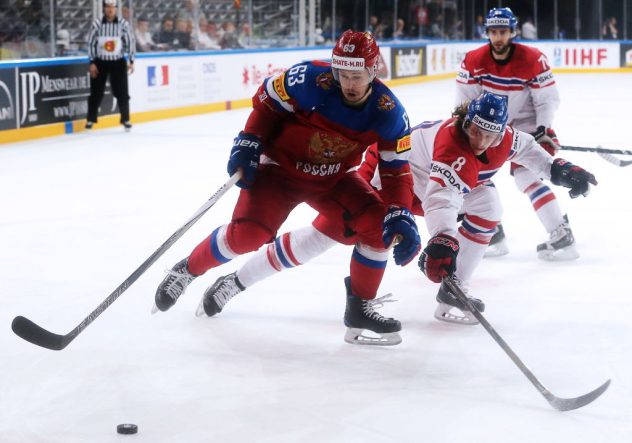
[11,172,241,351]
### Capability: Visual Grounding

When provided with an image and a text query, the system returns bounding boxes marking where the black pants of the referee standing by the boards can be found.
[88,58,129,123]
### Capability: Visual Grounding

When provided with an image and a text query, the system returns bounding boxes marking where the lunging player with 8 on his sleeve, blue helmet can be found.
[195,93,596,324]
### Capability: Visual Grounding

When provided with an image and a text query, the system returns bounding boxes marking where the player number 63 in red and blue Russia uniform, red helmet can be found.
[155,30,420,344]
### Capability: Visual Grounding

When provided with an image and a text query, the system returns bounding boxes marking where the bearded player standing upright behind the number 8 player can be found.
[456,8,579,260]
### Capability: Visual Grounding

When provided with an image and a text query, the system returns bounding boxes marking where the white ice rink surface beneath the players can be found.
[0,74,632,443]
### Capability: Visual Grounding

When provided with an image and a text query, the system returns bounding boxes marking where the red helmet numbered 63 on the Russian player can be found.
[331,29,380,81]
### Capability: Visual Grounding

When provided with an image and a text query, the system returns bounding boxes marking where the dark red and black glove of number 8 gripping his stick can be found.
[419,234,459,283]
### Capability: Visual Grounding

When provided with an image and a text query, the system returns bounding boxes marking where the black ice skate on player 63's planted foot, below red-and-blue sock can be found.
[345,277,402,346]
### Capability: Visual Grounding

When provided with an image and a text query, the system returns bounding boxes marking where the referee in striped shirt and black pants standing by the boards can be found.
[86,0,136,131]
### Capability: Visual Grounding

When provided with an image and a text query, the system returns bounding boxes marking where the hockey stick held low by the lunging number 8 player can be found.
[443,277,610,411]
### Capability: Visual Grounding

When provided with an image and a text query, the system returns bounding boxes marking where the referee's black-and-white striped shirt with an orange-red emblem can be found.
[88,17,136,63]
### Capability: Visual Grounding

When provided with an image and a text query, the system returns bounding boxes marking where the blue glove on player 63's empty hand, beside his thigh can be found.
[382,207,421,266]
